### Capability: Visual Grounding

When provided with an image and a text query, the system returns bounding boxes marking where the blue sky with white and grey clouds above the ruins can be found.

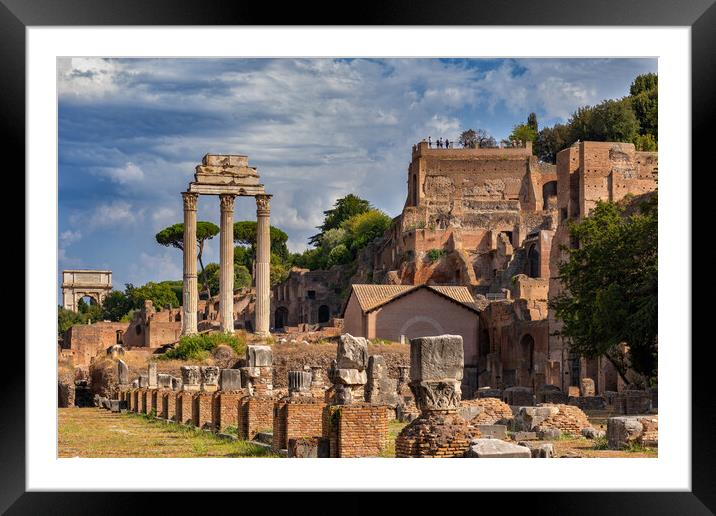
[57,58,657,300]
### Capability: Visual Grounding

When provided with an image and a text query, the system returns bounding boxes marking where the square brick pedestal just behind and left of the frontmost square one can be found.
[273,397,326,450]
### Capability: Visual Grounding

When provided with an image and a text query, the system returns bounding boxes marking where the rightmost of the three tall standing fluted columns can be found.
[255,195,271,335]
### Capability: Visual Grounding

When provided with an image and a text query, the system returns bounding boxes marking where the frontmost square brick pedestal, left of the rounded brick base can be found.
[323,403,388,458]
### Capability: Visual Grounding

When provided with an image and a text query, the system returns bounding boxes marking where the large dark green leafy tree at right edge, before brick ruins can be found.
[550,194,658,383]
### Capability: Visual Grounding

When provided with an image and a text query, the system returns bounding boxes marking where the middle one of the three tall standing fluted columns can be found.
[219,194,234,333]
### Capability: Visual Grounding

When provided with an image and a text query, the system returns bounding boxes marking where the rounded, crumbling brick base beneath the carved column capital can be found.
[395,414,480,458]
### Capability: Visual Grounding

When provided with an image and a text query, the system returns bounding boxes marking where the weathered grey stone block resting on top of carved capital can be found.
[410,335,465,381]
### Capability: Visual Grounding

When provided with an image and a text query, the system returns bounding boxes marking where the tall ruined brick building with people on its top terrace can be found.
[364,142,557,292]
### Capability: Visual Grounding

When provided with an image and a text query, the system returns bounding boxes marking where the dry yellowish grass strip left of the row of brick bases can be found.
[57,408,272,458]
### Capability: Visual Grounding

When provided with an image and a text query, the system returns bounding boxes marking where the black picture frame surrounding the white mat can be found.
[0,0,716,515]
